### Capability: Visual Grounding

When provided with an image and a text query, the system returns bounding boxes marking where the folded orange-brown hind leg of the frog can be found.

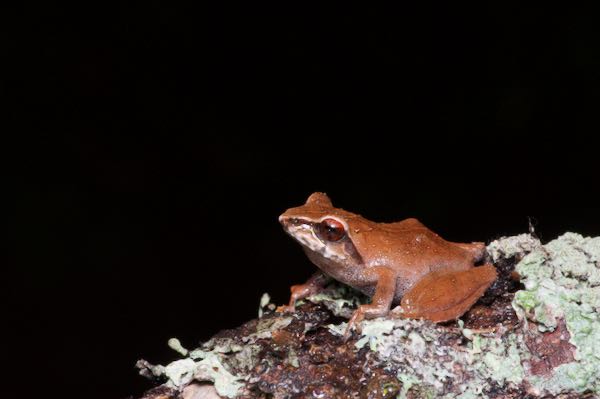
[394,264,497,323]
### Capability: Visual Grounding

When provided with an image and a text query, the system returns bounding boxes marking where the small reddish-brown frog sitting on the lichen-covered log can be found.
[279,193,496,336]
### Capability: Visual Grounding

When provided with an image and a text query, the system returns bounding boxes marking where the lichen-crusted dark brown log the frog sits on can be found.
[138,233,600,399]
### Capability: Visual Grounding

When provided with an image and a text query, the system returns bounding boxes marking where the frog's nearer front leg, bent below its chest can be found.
[344,267,397,339]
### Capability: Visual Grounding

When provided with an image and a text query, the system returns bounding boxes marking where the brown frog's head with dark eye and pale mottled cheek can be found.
[279,193,361,267]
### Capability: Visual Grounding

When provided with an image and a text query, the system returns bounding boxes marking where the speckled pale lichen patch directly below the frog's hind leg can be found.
[377,321,528,398]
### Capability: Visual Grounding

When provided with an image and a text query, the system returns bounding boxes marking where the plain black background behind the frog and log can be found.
[8,1,600,398]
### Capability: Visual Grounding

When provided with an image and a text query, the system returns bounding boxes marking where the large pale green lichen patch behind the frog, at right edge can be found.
[513,233,600,394]
